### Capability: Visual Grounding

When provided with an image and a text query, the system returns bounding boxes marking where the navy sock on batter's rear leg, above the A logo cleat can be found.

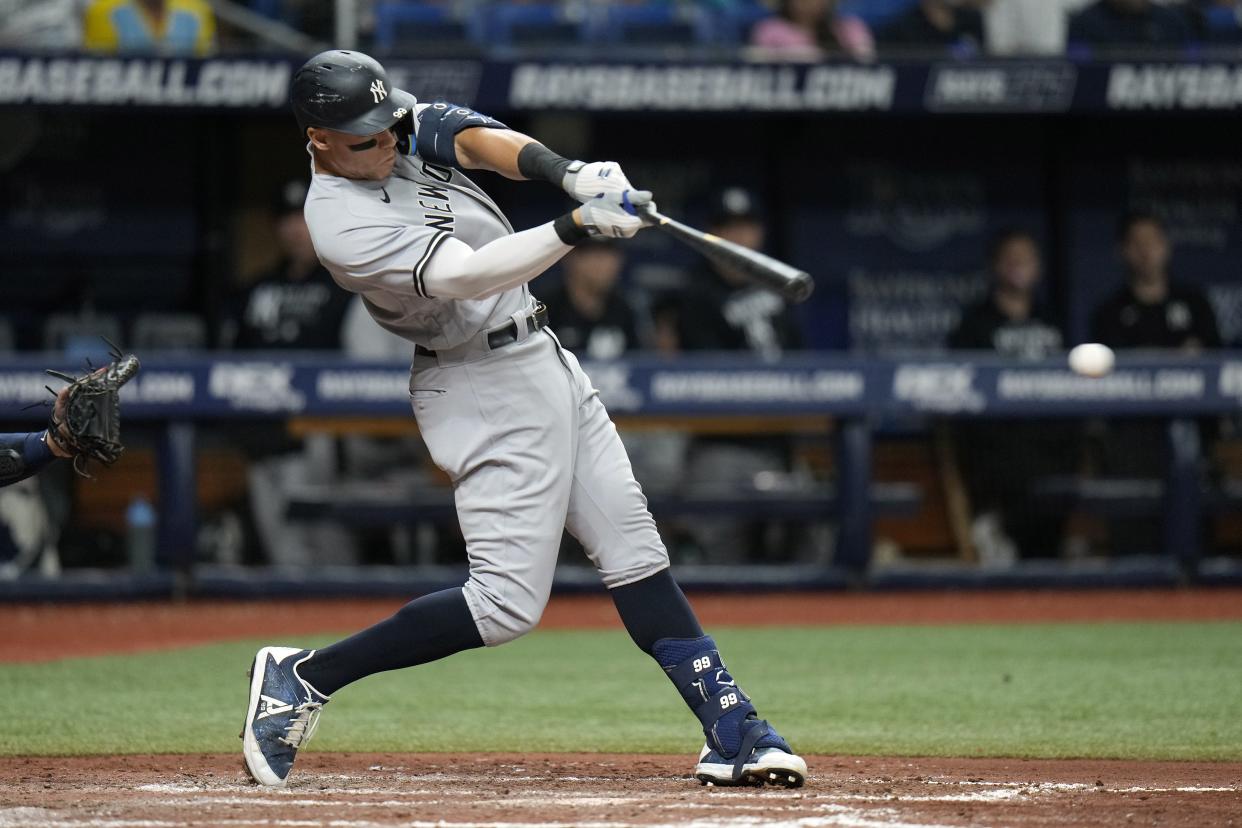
[298,588,483,695]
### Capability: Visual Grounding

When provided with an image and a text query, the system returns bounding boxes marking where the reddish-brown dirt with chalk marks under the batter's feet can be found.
[0,754,1242,828]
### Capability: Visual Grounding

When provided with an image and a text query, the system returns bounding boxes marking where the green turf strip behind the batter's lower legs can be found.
[0,623,1242,760]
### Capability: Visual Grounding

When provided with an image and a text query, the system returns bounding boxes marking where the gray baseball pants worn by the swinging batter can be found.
[410,329,668,647]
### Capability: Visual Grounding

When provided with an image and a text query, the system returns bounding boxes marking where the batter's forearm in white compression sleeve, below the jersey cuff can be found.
[422,222,573,299]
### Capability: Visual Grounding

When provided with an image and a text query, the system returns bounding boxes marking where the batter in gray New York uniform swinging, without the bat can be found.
[242,51,806,787]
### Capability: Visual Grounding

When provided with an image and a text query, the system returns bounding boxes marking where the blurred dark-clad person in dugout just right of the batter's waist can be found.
[544,241,640,360]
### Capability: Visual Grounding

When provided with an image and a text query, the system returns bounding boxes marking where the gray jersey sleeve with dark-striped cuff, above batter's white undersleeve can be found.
[314,225,451,298]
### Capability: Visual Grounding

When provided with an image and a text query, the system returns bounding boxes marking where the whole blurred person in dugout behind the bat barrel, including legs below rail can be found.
[656,187,801,564]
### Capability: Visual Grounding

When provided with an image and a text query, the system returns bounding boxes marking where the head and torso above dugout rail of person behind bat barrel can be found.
[656,187,802,360]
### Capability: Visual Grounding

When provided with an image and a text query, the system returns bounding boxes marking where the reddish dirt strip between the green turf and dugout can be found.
[0,590,1242,662]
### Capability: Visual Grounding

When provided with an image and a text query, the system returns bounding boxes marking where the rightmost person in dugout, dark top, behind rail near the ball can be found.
[1092,212,1221,554]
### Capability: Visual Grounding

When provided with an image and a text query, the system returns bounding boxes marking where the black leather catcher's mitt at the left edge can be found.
[47,343,138,477]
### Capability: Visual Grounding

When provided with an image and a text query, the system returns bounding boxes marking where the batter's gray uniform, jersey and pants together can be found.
[306,114,668,646]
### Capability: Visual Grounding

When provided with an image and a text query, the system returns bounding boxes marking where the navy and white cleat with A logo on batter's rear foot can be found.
[241,647,328,786]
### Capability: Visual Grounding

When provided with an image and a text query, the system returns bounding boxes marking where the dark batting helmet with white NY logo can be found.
[289,48,419,135]
